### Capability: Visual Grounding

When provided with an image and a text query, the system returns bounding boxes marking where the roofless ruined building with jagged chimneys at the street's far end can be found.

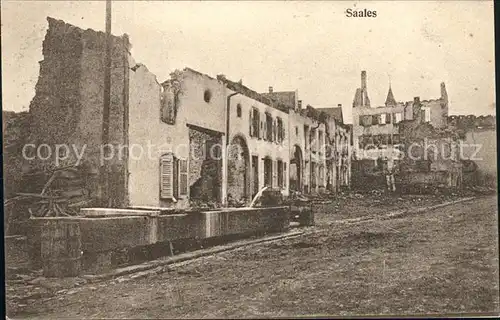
[352,71,460,187]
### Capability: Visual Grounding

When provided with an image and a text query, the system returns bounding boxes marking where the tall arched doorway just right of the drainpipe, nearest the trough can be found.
[227,135,251,206]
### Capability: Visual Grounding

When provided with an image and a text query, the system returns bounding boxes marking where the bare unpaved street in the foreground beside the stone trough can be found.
[7,197,499,319]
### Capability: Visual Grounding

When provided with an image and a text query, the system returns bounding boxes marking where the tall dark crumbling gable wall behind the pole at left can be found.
[27,18,128,206]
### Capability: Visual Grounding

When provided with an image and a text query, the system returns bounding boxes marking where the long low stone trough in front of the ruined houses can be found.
[28,207,290,277]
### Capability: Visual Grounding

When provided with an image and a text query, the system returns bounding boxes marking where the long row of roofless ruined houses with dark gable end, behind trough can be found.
[26,18,352,208]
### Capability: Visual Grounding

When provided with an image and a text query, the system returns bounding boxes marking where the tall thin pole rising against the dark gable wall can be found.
[101,0,112,207]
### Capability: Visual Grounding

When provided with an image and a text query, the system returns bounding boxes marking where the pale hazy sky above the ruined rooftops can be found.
[1,0,495,123]
